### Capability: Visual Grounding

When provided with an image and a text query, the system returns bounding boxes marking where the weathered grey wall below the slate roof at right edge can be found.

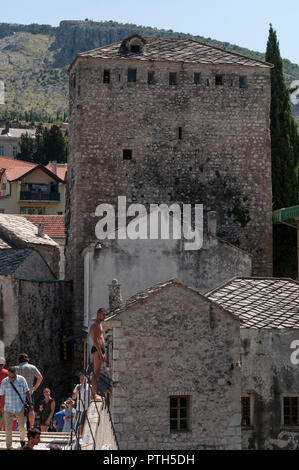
[241,328,299,450]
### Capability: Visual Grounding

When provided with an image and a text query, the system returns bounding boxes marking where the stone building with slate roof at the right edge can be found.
[207,278,299,450]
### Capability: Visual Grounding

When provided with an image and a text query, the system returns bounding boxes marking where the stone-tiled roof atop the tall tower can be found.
[70,35,272,68]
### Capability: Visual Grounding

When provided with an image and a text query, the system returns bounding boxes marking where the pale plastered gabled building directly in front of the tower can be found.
[82,212,251,327]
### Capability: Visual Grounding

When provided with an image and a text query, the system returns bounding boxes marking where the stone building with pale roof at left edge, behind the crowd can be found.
[0,216,74,401]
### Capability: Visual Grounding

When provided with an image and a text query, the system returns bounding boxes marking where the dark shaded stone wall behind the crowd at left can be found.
[0,279,74,403]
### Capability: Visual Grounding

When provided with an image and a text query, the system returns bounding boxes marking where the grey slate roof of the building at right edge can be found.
[205,278,299,328]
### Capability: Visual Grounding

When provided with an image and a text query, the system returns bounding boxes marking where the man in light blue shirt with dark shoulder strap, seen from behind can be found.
[0,367,33,449]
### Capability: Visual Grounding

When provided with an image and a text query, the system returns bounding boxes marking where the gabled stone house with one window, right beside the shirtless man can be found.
[103,280,241,450]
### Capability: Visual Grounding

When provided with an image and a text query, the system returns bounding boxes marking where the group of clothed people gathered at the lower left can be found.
[0,353,90,450]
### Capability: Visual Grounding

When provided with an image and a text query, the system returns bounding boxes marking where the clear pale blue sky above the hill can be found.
[0,0,299,64]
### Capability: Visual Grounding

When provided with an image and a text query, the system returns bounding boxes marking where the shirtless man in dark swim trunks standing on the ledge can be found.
[90,308,106,400]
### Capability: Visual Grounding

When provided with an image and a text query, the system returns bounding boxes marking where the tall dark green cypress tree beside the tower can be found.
[265,25,299,277]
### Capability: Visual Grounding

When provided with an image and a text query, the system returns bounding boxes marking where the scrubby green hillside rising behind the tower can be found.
[0,21,299,119]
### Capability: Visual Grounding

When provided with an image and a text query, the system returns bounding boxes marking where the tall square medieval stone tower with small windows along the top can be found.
[66,35,272,364]
